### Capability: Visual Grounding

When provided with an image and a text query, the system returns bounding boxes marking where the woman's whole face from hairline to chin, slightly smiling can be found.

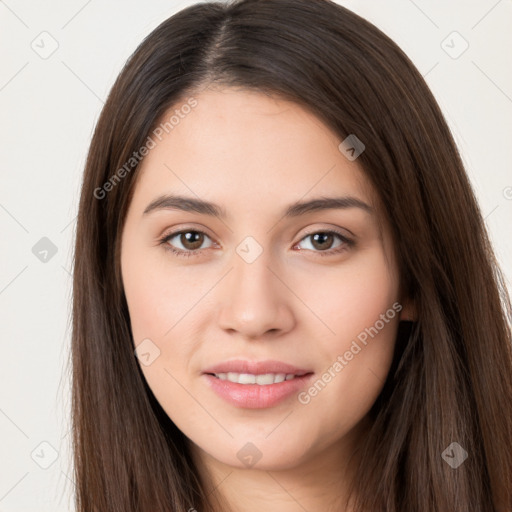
[117,88,404,469]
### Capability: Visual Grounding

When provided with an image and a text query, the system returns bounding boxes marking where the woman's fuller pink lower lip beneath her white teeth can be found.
[203,373,313,409]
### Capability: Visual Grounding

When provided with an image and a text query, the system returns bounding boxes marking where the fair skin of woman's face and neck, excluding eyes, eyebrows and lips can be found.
[121,88,411,512]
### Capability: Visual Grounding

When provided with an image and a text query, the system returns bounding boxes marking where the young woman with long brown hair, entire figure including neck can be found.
[72,0,512,512]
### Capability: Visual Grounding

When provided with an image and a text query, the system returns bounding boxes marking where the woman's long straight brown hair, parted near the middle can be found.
[72,0,512,512]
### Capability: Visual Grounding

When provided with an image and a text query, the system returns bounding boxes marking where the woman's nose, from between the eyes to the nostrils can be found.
[218,247,295,339]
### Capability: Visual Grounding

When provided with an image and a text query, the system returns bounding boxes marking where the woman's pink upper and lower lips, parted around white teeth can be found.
[202,360,313,409]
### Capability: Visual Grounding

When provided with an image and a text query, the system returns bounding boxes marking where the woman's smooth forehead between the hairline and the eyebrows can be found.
[128,88,374,214]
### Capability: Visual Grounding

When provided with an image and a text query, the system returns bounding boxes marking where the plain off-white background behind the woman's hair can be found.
[0,0,512,512]
